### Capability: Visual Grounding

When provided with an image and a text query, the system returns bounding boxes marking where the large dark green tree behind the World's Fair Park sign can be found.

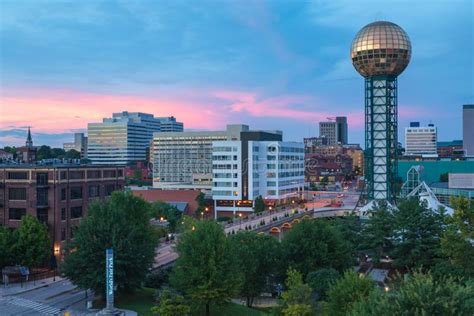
[62,192,158,293]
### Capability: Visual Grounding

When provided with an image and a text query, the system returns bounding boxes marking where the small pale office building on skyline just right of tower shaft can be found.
[405,124,438,157]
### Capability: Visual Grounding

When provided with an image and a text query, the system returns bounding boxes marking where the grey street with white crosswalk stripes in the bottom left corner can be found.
[0,280,89,316]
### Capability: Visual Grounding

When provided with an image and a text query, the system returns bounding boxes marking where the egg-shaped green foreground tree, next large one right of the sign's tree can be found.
[170,220,242,315]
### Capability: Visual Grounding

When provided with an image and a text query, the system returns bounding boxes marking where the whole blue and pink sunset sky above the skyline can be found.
[0,0,474,147]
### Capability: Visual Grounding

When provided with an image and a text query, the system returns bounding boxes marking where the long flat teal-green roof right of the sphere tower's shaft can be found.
[398,160,474,184]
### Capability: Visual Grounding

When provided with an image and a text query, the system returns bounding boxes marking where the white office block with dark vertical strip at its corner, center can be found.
[212,141,304,218]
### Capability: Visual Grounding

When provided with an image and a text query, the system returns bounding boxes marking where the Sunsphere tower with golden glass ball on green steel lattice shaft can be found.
[351,21,411,202]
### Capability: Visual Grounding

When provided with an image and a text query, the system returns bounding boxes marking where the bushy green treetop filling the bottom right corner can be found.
[350,272,474,316]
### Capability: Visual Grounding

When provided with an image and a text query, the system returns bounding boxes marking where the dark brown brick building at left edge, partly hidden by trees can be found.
[0,164,124,262]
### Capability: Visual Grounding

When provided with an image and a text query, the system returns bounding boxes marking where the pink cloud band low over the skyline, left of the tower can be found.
[0,87,364,133]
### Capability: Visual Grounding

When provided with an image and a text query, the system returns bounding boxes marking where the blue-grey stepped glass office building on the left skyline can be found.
[87,112,183,165]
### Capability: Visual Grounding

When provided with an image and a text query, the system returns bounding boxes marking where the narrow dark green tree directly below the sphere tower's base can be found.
[360,202,395,262]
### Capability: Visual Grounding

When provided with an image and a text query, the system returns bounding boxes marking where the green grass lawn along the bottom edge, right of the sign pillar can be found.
[115,288,269,316]
